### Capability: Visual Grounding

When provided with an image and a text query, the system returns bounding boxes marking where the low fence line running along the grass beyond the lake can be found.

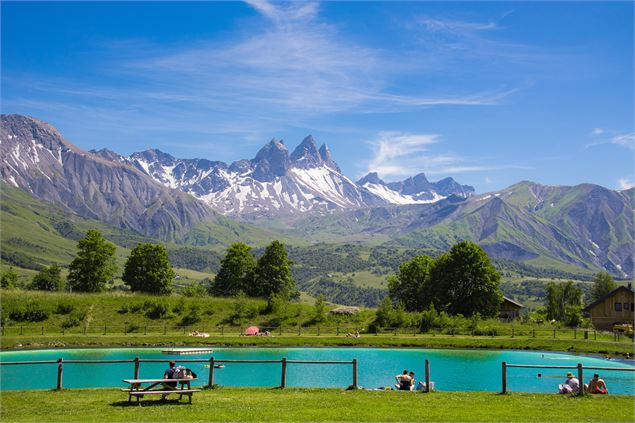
[0,324,631,342]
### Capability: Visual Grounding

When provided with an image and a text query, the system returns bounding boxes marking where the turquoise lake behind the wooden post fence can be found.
[0,348,635,395]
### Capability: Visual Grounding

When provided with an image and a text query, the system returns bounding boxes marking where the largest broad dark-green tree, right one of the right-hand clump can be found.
[430,241,503,317]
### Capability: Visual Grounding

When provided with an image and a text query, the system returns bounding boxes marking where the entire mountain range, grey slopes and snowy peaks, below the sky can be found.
[0,115,635,277]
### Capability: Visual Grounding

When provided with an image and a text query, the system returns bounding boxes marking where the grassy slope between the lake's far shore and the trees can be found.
[0,290,633,354]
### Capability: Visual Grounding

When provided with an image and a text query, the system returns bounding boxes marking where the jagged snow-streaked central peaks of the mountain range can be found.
[127,135,473,217]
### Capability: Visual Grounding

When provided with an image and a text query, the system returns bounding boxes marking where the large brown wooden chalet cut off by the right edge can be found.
[582,283,635,330]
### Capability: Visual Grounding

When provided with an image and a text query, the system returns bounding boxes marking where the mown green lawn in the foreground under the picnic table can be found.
[0,388,635,422]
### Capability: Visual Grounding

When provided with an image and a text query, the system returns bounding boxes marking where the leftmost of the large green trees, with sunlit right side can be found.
[66,229,117,292]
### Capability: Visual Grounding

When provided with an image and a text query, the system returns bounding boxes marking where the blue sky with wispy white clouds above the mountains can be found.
[1,0,635,192]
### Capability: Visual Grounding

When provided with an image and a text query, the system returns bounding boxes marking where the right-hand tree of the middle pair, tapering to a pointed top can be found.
[253,240,297,300]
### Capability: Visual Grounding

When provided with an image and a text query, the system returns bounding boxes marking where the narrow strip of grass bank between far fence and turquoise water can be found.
[0,334,633,355]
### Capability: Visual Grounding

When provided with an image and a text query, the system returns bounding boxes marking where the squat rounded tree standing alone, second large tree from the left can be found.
[121,244,175,295]
